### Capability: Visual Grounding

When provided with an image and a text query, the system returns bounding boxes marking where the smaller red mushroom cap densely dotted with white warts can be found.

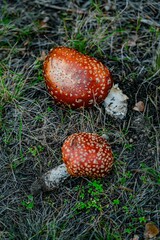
[62,133,113,178]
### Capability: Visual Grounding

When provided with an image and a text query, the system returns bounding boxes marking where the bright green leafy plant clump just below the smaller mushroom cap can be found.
[74,180,104,212]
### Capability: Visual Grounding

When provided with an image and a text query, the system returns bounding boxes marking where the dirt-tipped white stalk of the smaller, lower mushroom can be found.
[31,163,70,195]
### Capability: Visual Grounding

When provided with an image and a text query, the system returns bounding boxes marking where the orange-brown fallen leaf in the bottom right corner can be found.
[144,222,159,240]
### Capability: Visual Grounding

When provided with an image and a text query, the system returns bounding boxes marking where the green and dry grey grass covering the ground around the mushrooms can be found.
[0,0,160,240]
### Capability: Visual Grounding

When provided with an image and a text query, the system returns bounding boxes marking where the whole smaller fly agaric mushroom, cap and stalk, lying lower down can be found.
[31,132,113,194]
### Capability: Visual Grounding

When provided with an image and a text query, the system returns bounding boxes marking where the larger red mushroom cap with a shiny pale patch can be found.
[43,47,113,108]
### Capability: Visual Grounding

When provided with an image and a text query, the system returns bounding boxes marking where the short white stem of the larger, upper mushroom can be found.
[103,84,128,119]
